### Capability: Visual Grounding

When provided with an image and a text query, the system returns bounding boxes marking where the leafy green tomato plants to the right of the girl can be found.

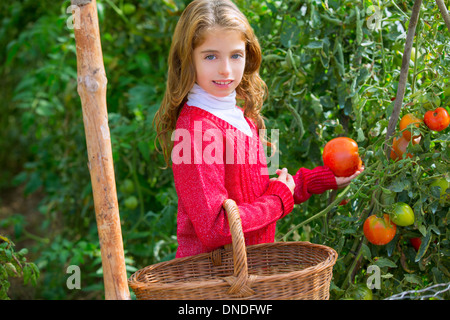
[255,1,450,299]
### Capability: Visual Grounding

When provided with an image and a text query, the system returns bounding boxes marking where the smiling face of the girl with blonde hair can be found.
[194,28,245,97]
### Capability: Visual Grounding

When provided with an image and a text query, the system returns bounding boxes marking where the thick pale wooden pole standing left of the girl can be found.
[72,0,130,300]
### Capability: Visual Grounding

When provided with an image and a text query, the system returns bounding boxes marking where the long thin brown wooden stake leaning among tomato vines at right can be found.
[384,0,422,159]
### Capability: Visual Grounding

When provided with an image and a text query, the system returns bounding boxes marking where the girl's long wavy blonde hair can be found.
[153,0,267,166]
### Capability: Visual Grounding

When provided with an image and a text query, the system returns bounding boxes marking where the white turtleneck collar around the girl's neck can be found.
[187,84,253,137]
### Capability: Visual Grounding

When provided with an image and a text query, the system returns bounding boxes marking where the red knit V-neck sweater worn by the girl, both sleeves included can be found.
[172,105,337,257]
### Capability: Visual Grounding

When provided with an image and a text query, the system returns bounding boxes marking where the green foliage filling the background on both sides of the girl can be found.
[0,0,450,299]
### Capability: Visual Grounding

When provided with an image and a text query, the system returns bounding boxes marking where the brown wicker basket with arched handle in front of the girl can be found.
[128,200,337,300]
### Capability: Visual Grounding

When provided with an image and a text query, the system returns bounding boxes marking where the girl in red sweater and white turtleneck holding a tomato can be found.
[154,0,360,257]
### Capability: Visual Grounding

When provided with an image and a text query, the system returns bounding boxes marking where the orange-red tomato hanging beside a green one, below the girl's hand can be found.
[363,214,397,246]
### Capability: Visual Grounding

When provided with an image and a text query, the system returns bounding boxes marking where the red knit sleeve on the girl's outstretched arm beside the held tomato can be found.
[293,166,337,204]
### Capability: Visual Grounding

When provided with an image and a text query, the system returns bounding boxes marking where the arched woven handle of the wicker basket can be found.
[223,199,255,297]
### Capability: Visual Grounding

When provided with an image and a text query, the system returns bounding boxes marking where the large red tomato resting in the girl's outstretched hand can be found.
[322,137,362,177]
